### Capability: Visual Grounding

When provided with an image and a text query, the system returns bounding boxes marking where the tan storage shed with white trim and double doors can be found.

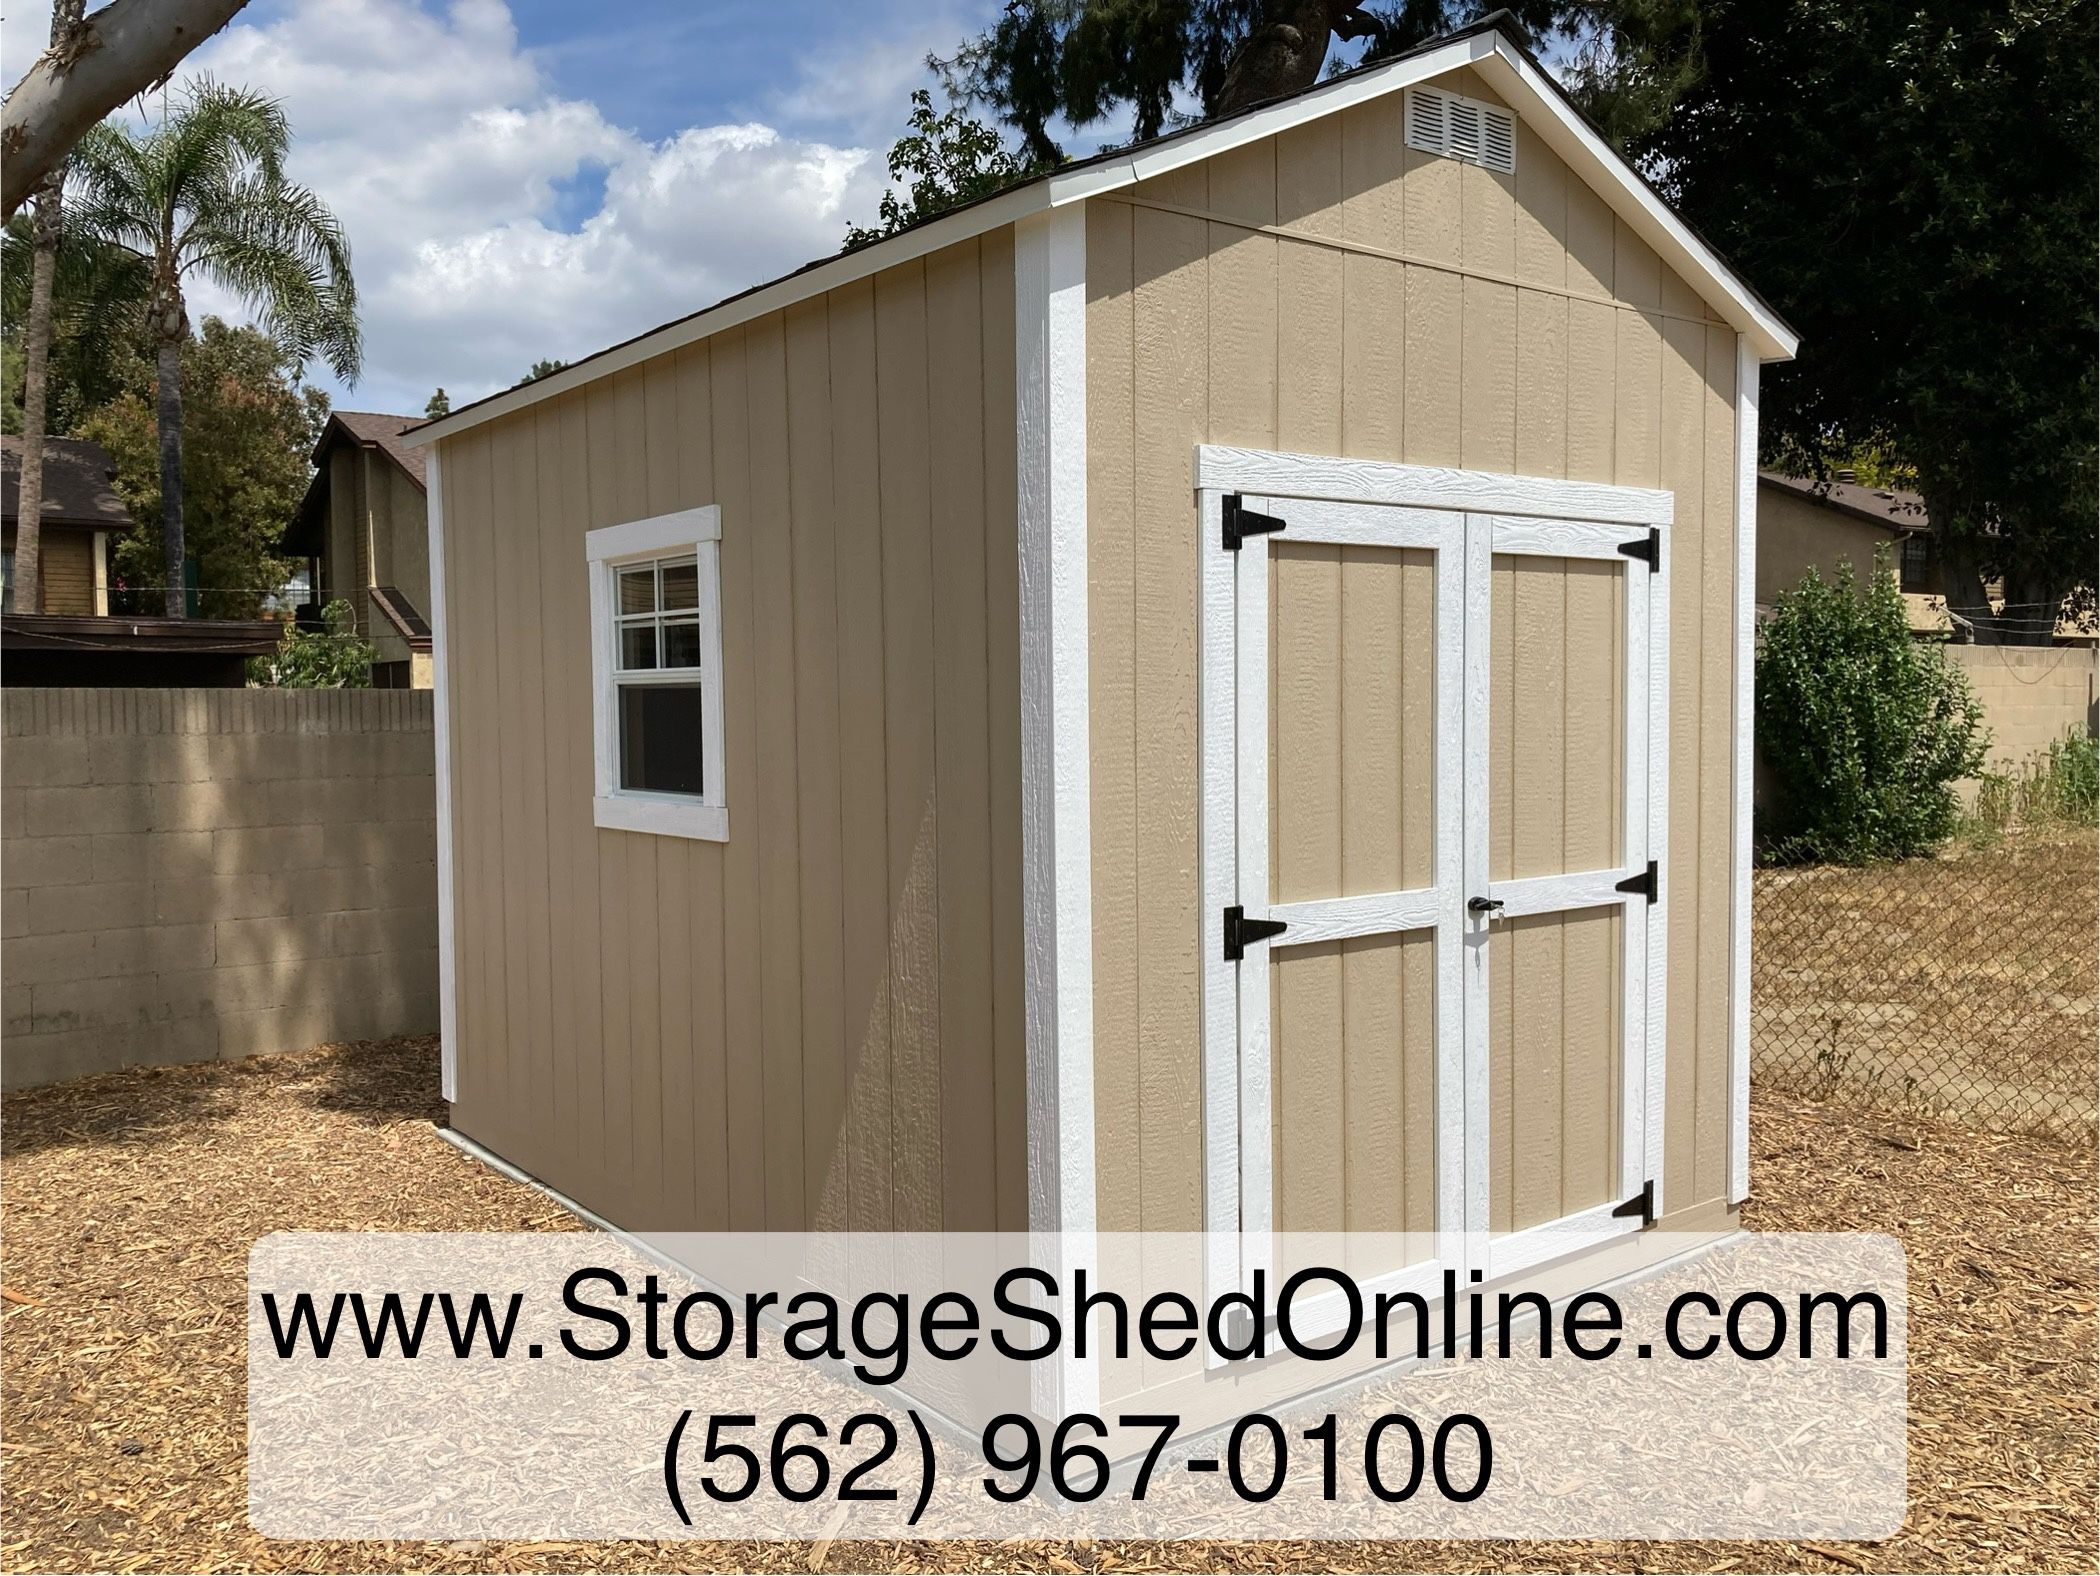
[412,12,1796,1420]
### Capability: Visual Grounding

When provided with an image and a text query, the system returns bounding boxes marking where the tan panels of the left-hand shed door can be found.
[1271,538,1436,1273]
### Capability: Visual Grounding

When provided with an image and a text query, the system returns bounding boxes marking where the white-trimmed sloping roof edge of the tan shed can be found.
[407,11,1800,445]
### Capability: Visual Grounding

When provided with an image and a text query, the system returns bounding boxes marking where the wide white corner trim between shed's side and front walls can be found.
[1014,208,1098,1416]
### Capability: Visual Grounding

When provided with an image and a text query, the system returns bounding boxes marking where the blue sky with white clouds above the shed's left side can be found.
[0,0,1016,412]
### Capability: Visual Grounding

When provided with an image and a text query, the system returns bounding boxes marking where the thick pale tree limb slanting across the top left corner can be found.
[0,0,246,219]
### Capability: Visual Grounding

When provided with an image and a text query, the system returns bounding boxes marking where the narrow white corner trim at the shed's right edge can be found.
[1728,334,1758,1204]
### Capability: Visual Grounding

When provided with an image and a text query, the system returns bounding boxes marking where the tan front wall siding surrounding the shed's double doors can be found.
[1088,64,1735,1319]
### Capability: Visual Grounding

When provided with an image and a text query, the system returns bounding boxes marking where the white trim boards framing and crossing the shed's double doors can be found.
[1195,445,1674,1319]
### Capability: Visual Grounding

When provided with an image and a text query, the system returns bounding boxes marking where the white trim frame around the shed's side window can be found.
[584,504,729,843]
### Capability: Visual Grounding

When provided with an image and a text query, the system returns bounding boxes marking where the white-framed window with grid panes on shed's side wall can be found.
[584,506,729,843]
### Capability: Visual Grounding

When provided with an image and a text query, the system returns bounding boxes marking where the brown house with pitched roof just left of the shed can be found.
[284,410,431,689]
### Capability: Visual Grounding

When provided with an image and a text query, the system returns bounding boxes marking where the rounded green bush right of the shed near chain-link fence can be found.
[1756,563,1989,864]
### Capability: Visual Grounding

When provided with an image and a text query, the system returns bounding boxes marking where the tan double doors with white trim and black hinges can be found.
[1199,481,1665,1319]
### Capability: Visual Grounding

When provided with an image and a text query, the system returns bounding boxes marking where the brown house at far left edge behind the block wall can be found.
[0,437,284,689]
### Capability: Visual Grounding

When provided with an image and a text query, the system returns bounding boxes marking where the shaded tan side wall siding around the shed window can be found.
[443,240,1027,1229]
